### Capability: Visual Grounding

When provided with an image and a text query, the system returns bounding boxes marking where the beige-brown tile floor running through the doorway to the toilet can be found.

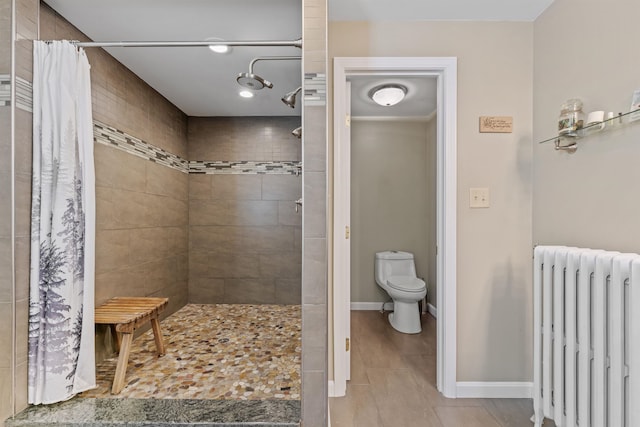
[329,311,553,427]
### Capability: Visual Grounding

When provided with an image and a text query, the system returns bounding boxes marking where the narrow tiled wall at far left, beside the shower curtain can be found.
[0,0,39,419]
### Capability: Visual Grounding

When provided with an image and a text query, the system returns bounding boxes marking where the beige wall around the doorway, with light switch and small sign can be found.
[329,22,533,381]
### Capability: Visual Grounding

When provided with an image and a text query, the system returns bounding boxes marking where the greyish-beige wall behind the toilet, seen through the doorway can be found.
[351,118,436,302]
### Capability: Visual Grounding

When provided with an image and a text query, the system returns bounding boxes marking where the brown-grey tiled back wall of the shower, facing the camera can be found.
[189,117,302,304]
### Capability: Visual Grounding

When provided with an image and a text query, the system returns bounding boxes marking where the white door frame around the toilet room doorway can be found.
[330,57,457,398]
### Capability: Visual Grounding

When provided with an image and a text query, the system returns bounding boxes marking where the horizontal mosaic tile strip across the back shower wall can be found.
[189,160,302,175]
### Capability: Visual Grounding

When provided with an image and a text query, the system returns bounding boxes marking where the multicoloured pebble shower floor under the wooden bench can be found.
[79,304,301,400]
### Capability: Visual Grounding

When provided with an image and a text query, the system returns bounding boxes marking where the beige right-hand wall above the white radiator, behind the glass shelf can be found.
[533,0,640,253]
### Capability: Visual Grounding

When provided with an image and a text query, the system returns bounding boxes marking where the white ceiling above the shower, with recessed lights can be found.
[45,0,302,116]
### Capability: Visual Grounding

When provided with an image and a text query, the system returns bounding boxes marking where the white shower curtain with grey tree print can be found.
[28,41,96,404]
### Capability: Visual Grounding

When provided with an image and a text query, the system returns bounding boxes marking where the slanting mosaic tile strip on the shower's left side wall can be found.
[93,120,189,173]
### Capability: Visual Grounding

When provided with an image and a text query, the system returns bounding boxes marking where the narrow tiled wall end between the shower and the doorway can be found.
[302,0,328,427]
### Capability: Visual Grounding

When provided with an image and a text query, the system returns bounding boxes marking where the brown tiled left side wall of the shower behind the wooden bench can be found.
[40,4,189,360]
